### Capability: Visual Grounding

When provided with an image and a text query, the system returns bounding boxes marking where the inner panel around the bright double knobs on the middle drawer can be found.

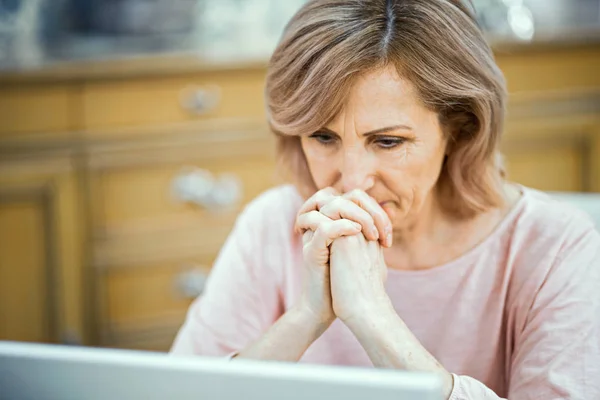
[93,155,275,230]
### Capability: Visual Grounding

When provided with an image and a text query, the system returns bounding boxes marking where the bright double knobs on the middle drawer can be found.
[173,168,242,210]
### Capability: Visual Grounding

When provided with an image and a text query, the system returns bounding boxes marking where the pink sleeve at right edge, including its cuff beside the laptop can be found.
[450,223,600,400]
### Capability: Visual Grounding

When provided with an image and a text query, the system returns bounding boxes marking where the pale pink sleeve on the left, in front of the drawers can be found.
[171,191,290,357]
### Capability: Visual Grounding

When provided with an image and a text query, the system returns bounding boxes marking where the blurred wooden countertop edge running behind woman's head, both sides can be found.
[0,28,600,84]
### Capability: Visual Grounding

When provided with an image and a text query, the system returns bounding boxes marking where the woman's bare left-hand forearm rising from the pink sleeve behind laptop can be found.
[236,307,331,362]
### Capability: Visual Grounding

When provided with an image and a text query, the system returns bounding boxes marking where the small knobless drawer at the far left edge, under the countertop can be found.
[0,85,74,138]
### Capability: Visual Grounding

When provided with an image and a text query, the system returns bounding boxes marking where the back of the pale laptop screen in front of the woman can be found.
[0,342,441,400]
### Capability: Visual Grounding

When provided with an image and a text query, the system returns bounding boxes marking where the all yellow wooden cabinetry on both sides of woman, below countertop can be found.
[0,45,600,351]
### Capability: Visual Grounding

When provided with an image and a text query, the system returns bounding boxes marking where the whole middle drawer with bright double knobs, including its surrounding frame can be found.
[89,126,277,262]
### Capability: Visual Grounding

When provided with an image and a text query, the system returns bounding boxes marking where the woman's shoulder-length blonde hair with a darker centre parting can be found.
[266,0,506,217]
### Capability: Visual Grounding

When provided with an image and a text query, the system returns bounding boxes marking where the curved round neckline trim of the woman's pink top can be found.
[387,184,529,277]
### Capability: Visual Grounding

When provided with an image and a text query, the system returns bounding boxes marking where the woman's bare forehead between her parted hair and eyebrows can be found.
[330,67,427,130]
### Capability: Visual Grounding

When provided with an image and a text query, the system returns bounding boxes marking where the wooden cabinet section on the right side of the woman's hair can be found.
[497,47,600,192]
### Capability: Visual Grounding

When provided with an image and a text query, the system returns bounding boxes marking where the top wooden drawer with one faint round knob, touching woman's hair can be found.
[83,70,265,130]
